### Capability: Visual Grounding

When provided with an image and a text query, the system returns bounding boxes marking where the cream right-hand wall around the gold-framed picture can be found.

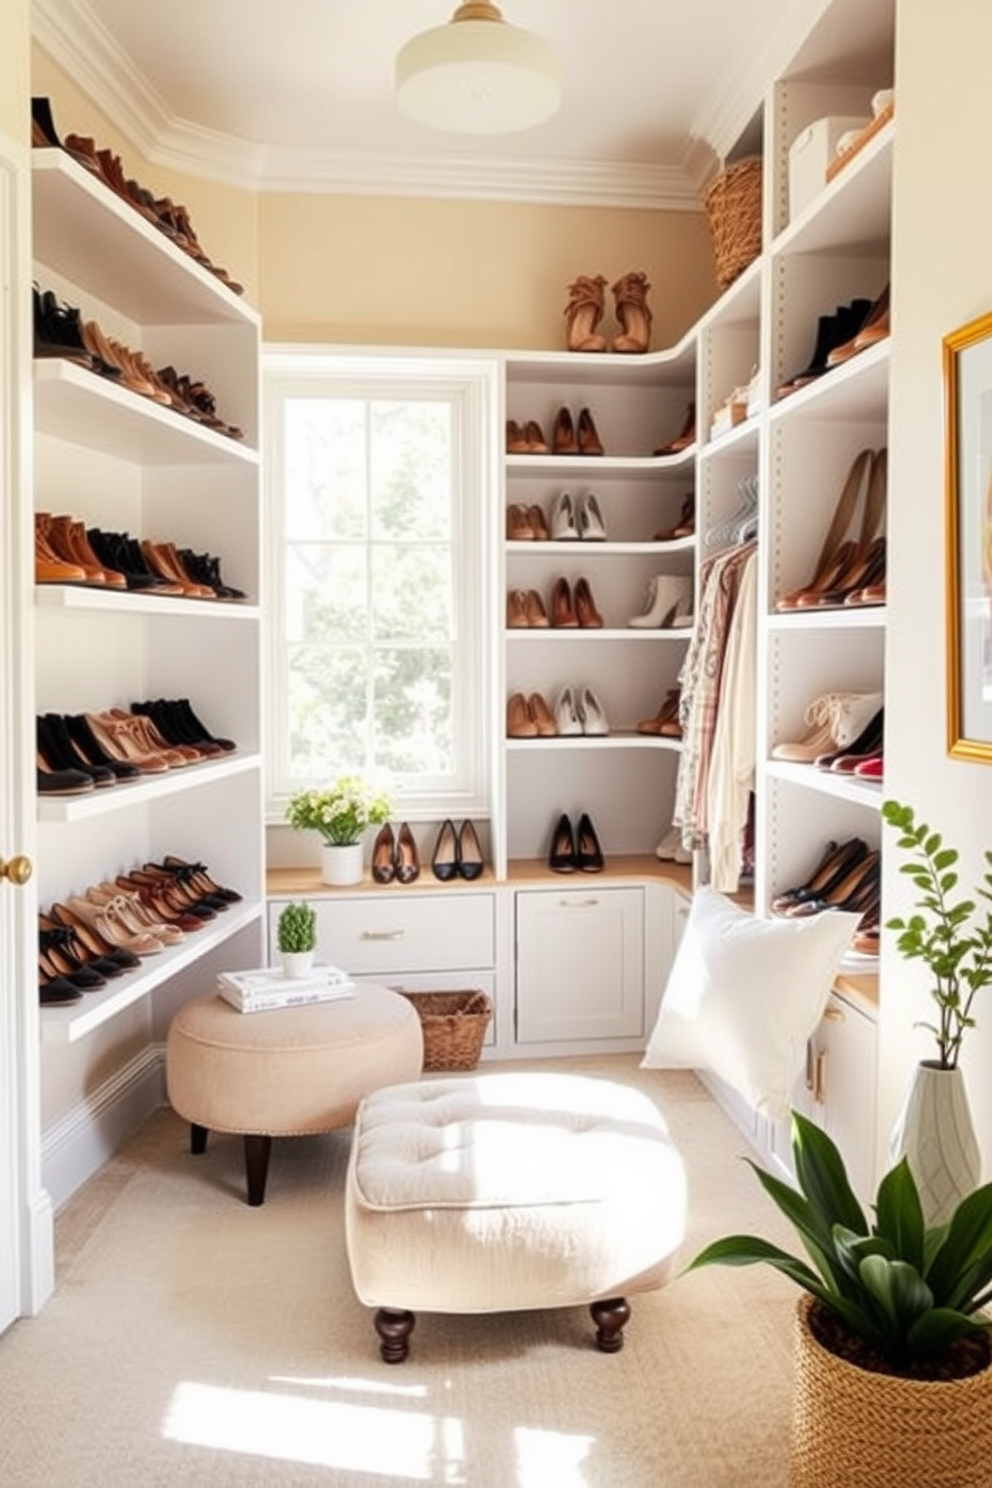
[879,0,992,1180]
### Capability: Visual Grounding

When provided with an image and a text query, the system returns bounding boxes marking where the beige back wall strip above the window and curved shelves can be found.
[259,193,717,350]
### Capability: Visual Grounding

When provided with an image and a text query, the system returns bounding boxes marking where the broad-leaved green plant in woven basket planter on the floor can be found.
[689,1112,992,1488]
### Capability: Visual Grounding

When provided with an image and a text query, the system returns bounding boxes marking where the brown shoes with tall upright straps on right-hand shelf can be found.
[775,448,888,610]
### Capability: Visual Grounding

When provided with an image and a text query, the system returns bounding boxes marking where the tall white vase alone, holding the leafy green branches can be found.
[889,1061,982,1226]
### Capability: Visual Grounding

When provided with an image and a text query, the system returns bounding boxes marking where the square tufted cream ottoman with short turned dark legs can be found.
[345,1073,686,1364]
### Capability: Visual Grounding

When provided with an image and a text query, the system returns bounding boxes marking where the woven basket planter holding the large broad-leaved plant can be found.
[788,1296,992,1488]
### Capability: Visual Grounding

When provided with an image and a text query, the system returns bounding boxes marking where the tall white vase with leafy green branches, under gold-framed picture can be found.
[882,801,992,1223]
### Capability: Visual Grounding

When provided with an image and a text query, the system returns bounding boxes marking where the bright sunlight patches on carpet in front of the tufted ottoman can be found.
[162,1379,592,1488]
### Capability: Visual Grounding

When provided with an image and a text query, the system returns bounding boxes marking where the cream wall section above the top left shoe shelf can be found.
[32,48,259,305]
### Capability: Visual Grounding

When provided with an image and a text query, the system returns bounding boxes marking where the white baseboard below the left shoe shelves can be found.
[42,1045,165,1210]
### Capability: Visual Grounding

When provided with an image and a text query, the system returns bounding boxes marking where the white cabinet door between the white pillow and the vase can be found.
[812,995,877,1201]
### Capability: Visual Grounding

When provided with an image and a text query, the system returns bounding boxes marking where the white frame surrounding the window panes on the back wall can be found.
[262,345,500,824]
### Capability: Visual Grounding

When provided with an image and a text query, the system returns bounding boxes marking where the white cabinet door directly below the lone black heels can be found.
[516,888,644,1043]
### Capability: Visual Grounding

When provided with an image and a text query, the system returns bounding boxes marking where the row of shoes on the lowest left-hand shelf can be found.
[39,854,242,1007]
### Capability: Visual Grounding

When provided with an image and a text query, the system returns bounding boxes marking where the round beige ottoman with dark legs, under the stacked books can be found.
[165,982,424,1204]
